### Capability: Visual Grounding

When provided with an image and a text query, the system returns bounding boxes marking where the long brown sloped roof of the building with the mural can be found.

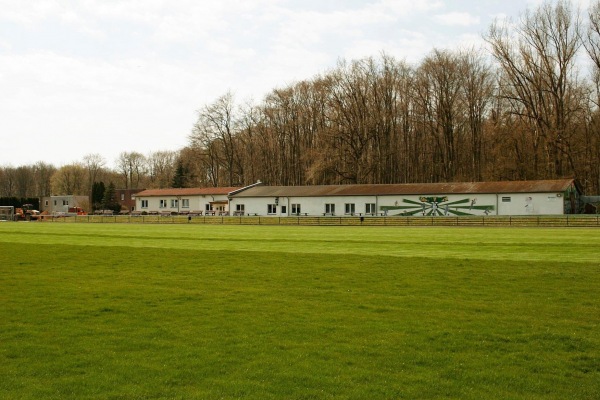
[232,179,574,197]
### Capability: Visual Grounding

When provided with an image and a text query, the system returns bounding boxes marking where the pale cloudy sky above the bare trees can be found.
[0,0,587,167]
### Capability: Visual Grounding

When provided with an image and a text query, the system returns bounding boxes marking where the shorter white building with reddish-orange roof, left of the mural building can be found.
[135,187,241,215]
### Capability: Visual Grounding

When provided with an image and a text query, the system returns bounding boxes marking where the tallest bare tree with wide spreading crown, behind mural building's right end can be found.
[486,1,581,177]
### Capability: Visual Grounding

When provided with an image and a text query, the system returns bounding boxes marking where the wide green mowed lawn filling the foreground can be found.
[0,222,600,399]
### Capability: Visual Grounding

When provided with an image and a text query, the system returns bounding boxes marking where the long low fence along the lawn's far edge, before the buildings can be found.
[31,215,600,227]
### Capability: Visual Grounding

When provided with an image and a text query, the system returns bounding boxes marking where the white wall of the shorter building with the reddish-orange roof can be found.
[135,195,229,212]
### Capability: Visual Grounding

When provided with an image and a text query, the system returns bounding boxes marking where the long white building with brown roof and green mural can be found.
[229,179,581,216]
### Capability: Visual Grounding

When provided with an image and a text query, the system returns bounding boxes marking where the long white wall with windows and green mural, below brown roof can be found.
[230,193,565,216]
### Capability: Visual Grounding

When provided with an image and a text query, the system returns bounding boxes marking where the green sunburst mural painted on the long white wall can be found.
[381,196,494,216]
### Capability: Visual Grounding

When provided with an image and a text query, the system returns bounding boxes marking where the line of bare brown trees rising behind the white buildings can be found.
[0,0,600,197]
